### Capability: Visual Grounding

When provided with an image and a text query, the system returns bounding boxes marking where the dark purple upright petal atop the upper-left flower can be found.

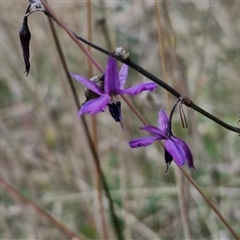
[104,57,120,95]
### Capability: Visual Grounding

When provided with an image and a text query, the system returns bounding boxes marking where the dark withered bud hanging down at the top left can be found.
[19,17,31,76]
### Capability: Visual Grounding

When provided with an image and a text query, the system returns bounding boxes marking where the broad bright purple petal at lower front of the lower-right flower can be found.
[164,138,186,166]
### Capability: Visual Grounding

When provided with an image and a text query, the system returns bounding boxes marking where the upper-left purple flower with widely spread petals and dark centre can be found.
[70,57,157,123]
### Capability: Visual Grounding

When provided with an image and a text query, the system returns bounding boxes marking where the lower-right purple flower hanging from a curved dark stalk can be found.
[129,106,194,171]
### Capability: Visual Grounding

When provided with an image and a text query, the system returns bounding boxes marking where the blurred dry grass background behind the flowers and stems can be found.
[0,1,240,239]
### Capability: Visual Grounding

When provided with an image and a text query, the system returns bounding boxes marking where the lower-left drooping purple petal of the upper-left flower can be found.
[78,95,109,117]
